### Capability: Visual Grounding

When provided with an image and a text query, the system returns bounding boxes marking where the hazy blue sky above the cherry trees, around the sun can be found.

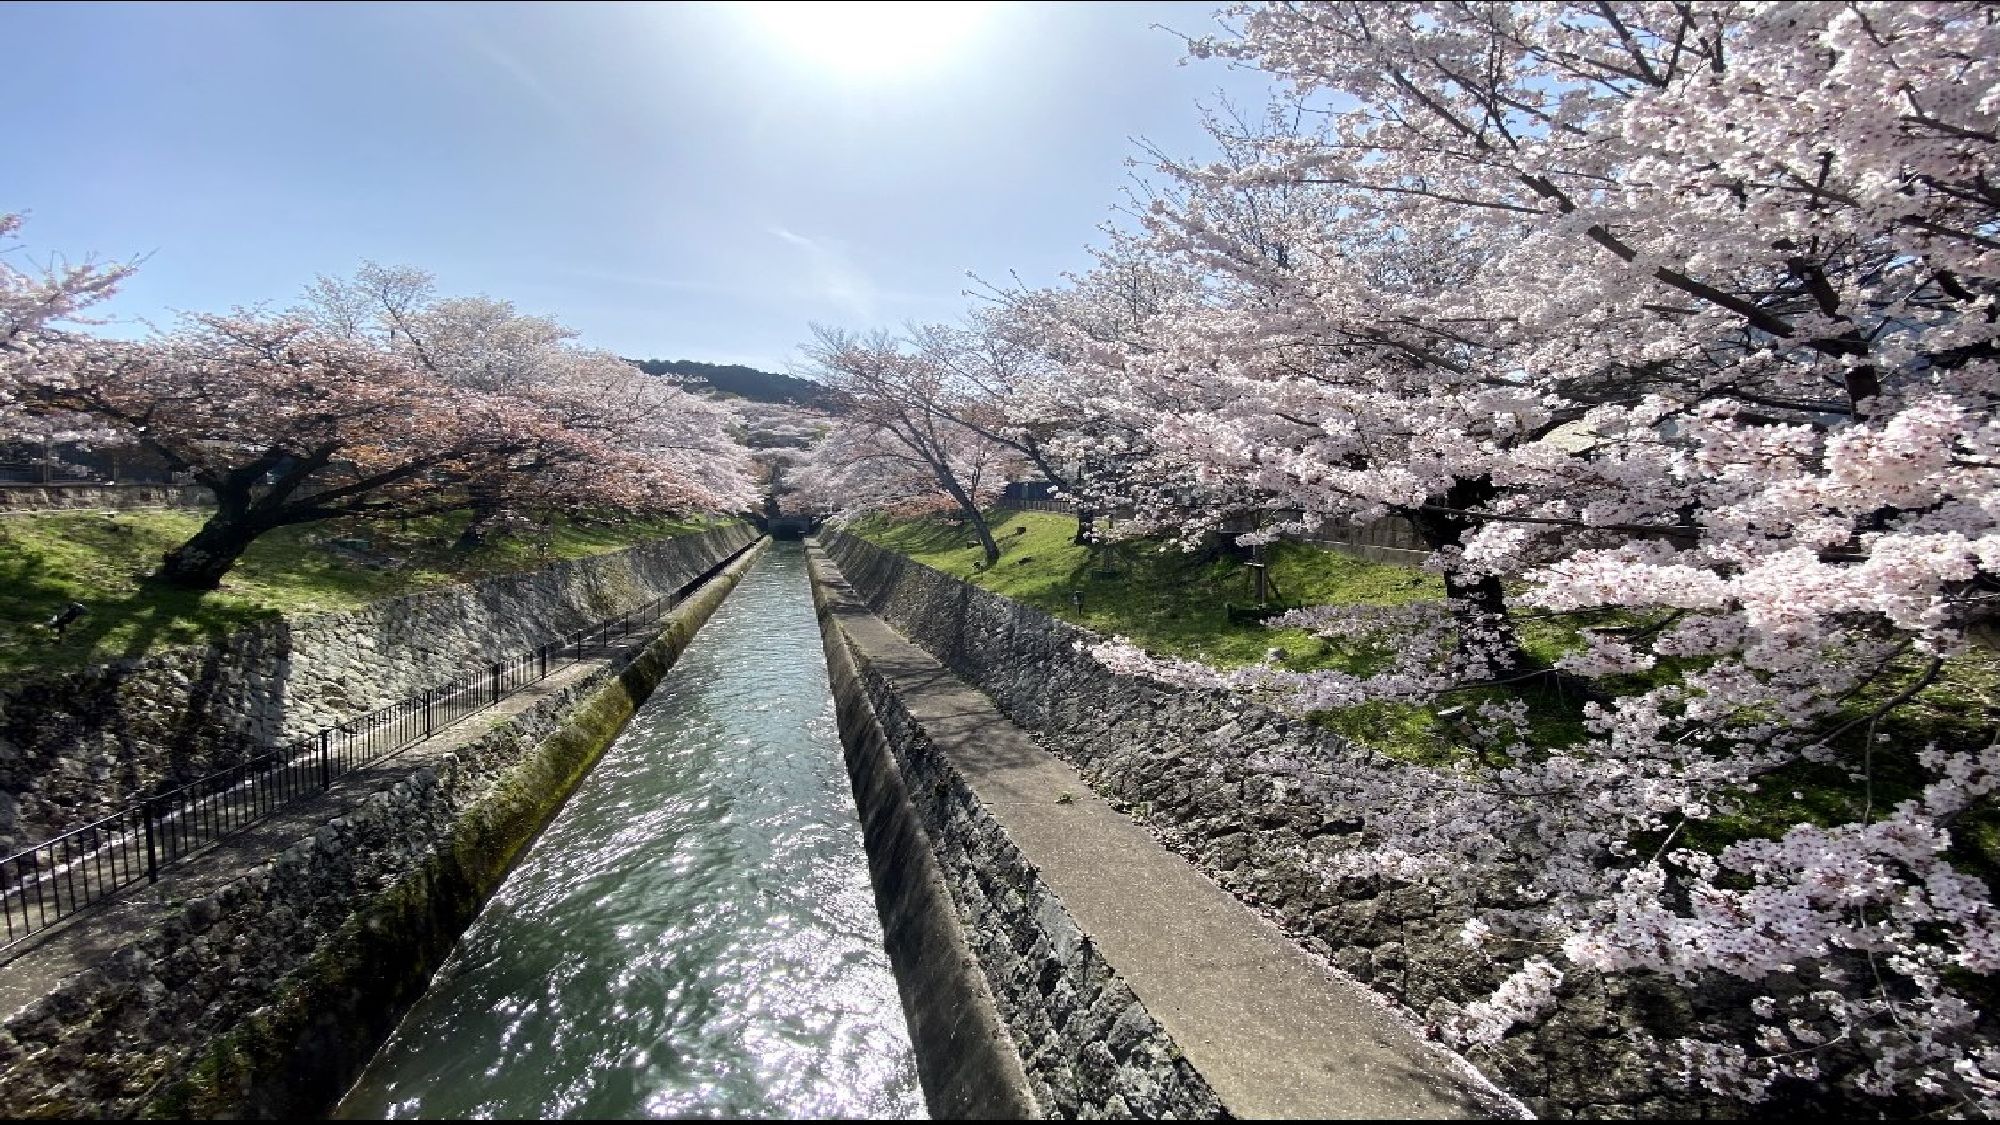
[0,4,1264,368]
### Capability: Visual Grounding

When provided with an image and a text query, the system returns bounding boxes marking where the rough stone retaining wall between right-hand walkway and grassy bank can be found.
[822,532,1776,1117]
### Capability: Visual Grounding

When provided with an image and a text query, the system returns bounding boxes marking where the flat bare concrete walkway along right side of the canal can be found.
[814,550,1522,1119]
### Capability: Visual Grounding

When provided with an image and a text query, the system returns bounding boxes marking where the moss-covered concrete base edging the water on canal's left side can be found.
[140,544,762,1117]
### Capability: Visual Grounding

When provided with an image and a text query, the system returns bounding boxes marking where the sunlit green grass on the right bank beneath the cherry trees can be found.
[850,510,2000,873]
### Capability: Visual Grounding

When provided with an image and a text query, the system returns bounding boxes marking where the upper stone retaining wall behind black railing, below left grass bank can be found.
[0,524,756,853]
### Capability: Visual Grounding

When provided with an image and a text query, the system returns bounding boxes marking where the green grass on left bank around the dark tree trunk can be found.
[0,508,728,673]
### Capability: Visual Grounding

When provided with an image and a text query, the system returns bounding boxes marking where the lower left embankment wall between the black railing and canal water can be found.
[0,542,760,1117]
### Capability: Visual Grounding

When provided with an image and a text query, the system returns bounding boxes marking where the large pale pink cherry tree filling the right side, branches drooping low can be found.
[1048,2,2000,1113]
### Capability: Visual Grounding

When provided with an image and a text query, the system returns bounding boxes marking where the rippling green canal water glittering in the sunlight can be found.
[334,542,924,1119]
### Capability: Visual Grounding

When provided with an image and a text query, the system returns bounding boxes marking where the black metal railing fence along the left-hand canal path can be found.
[0,552,738,949]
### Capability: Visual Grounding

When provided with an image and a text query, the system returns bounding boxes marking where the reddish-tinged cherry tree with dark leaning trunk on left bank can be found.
[19,306,594,591]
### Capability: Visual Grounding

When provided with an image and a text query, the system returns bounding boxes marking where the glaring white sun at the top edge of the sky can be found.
[742,0,992,78]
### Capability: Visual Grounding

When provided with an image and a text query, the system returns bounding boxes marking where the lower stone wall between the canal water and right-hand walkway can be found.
[814,548,1222,1119]
